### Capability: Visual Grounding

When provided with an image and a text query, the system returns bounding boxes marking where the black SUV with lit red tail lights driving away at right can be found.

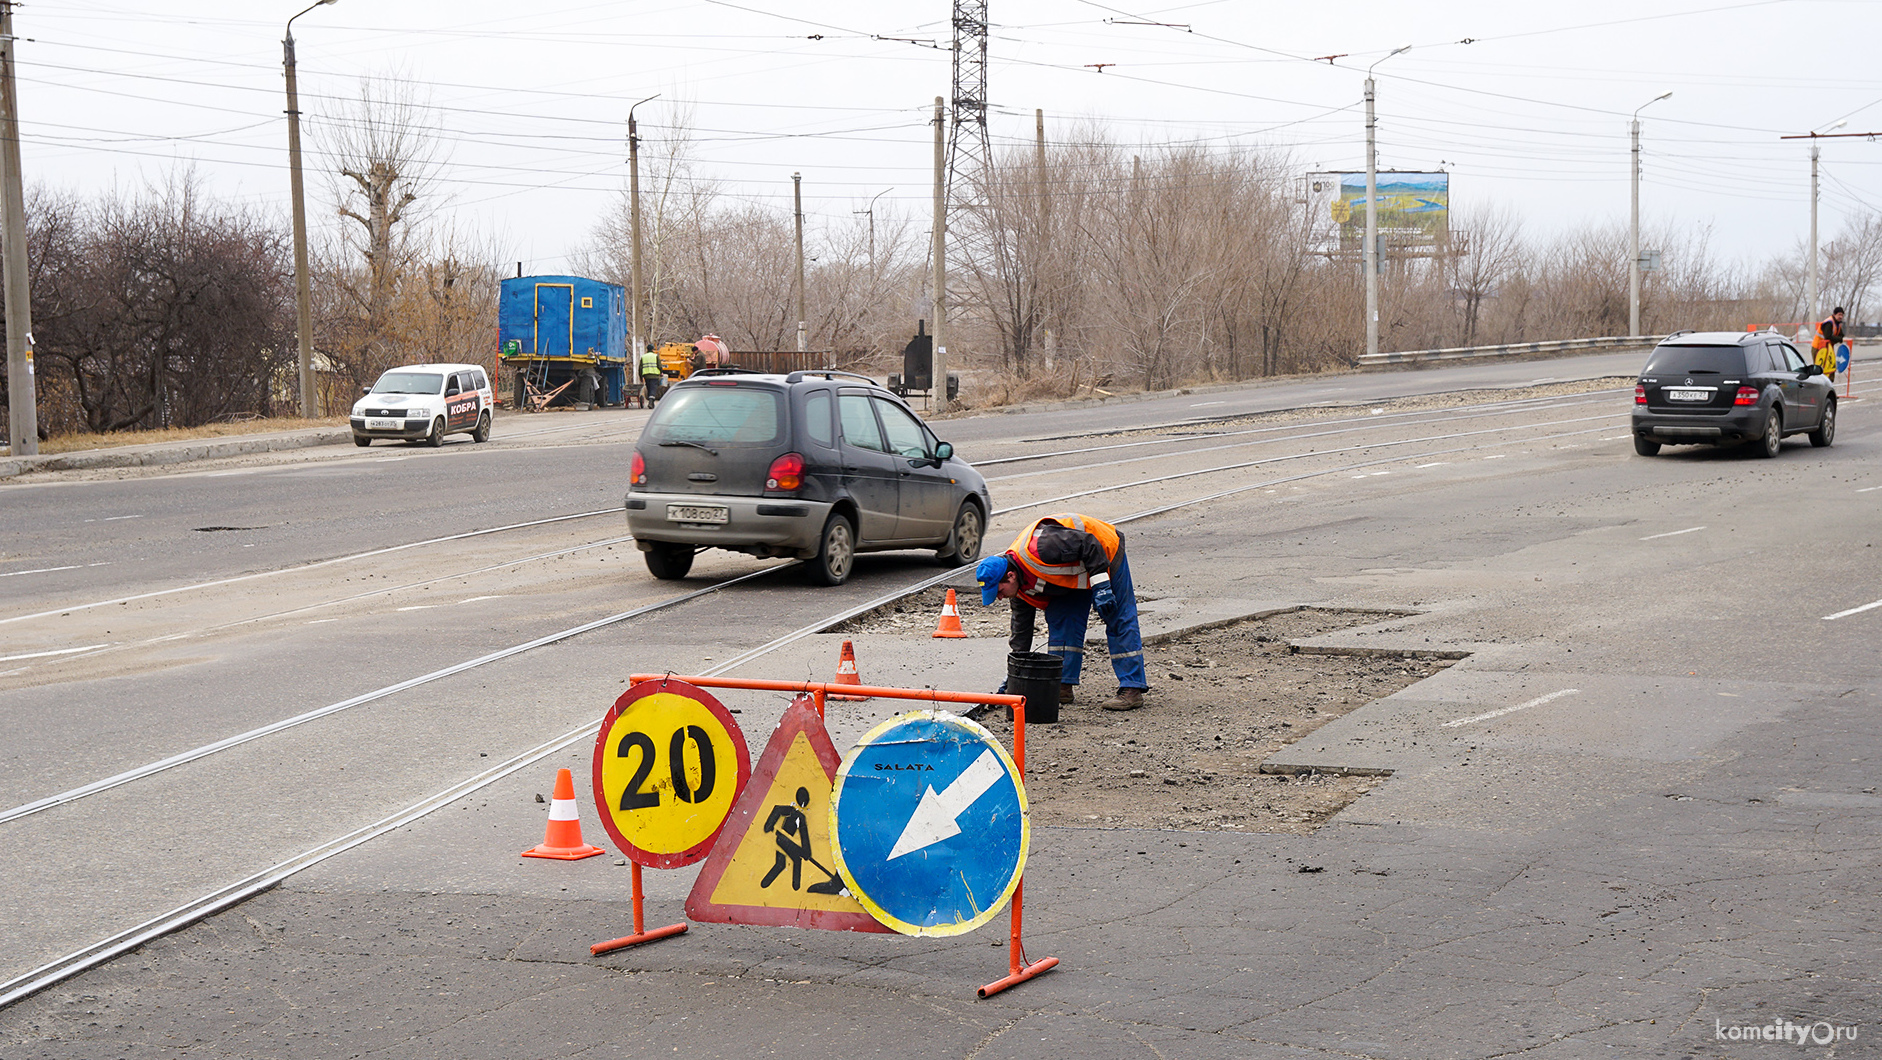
[1634,331,1837,458]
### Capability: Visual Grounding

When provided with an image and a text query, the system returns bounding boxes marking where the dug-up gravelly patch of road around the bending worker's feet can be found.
[830,606,1453,834]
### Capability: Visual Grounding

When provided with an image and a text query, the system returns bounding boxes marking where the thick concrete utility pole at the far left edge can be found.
[0,0,40,456]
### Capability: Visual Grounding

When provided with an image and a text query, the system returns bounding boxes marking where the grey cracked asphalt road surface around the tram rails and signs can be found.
[0,356,1882,1060]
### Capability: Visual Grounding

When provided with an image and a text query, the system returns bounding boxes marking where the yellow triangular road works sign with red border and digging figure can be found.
[687,697,890,932]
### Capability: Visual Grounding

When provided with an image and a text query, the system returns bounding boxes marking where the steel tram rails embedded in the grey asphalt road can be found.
[0,374,1874,1007]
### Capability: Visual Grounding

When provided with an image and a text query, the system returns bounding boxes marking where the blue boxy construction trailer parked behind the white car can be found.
[497,277,629,409]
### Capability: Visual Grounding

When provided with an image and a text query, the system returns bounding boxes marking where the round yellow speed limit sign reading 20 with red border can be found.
[595,678,751,868]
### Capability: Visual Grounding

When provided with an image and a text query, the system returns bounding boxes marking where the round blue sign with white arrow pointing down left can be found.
[830,710,1031,936]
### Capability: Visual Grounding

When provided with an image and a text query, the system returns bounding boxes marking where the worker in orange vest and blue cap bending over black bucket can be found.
[975,512,1150,710]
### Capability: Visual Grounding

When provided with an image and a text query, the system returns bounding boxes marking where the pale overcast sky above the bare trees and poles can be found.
[15,0,1882,273]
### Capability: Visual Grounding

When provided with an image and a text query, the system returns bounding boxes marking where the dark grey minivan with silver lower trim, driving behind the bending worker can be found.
[627,367,992,586]
